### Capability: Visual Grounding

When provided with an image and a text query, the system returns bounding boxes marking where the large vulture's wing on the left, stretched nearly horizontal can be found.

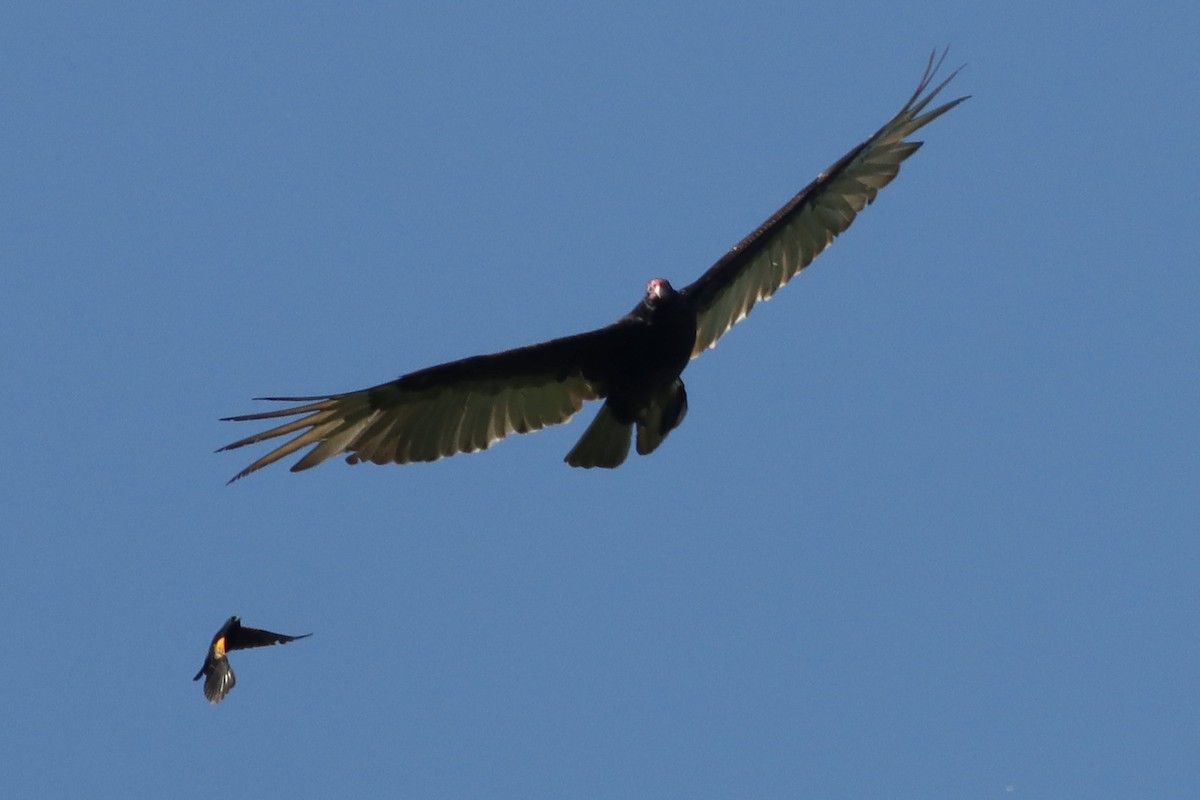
[218,323,622,482]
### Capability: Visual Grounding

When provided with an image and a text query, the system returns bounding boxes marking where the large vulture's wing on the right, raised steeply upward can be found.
[682,53,966,357]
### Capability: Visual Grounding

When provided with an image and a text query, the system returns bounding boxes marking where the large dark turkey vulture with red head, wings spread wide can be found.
[221,53,966,482]
